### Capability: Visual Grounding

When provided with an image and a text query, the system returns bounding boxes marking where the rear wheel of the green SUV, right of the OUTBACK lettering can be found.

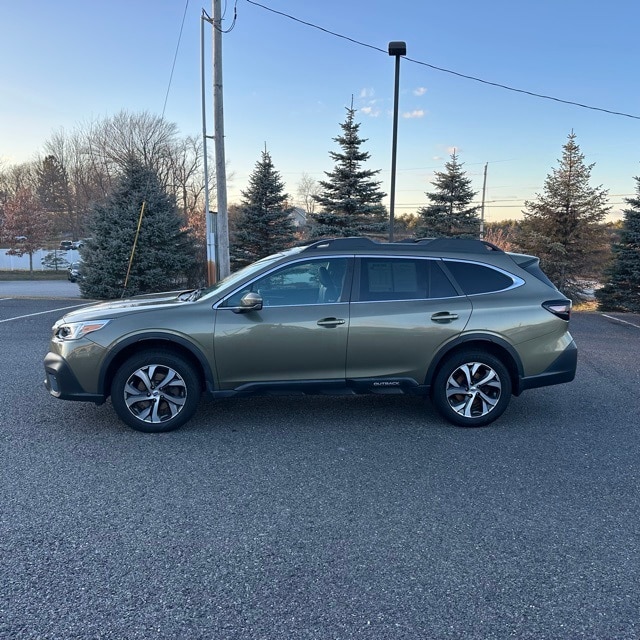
[431,351,512,427]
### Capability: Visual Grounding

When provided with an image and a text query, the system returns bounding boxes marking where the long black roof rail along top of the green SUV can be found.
[303,236,504,253]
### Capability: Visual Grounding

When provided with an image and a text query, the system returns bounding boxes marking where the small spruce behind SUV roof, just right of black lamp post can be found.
[418,151,480,238]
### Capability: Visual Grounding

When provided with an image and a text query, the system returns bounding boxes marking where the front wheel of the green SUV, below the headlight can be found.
[111,350,201,433]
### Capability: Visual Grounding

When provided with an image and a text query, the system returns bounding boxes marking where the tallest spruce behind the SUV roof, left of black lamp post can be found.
[310,105,388,238]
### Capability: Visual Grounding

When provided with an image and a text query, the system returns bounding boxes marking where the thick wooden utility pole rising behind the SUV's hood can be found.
[212,0,231,279]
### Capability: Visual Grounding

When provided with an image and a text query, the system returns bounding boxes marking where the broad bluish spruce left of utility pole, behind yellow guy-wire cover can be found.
[80,159,195,298]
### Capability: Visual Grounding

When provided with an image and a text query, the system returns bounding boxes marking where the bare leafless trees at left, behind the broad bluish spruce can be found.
[0,111,205,284]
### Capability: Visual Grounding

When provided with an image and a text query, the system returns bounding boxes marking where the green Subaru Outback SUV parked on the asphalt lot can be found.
[44,238,577,432]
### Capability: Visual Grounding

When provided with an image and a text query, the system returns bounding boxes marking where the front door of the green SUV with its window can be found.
[214,258,350,390]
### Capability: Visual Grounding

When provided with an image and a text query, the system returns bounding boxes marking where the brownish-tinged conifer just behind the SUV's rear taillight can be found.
[519,132,611,301]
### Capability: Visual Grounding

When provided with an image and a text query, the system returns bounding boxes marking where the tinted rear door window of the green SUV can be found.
[360,258,457,301]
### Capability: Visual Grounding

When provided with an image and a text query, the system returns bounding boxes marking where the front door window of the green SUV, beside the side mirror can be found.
[223,258,347,307]
